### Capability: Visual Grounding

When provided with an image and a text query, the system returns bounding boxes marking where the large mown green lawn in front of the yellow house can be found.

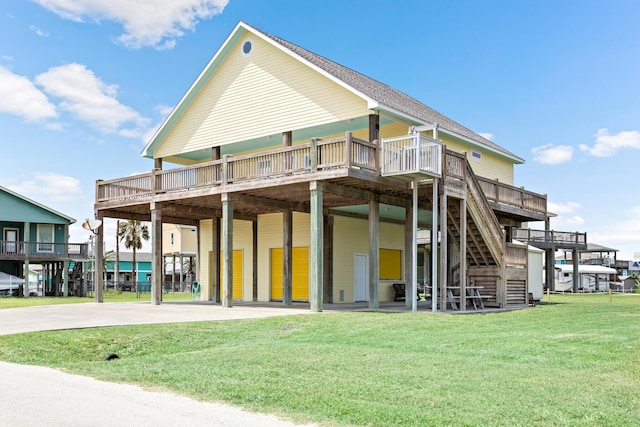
[0,295,640,426]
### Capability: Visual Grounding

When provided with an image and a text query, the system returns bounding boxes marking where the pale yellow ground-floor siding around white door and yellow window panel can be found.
[333,216,404,303]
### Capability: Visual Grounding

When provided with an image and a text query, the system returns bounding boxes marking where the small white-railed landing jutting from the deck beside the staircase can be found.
[380,133,442,177]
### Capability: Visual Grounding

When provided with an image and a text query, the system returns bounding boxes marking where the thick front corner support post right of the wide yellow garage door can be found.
[309,181,323,312]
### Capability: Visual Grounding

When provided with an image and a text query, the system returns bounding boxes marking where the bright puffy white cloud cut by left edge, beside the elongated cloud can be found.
[0,67,58,122]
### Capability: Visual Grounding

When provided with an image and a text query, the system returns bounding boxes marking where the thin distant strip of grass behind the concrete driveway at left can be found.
[0,290,191,310]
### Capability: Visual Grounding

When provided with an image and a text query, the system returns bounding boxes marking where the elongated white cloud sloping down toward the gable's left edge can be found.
[36,63,149,137]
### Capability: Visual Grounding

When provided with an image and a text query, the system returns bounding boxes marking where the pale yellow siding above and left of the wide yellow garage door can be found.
[258,212,310,301]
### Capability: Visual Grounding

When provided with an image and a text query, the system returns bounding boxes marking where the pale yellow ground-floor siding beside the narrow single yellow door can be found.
[199,220,253,301]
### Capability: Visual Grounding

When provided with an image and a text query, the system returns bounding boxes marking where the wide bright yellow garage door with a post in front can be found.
[271,246,309,301]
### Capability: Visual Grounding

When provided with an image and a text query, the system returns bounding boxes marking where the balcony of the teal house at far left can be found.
[0,240,88,261]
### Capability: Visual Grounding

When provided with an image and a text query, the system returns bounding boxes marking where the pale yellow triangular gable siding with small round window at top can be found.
[155,37,370,157]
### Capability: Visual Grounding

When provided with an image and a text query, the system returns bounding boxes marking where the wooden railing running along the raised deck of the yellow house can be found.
[96,133,547,222]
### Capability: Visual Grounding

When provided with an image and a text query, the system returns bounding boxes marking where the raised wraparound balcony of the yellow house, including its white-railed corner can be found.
[96,133,547,220]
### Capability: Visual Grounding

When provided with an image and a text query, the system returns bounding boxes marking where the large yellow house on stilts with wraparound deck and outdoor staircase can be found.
[95,22,586,311]
